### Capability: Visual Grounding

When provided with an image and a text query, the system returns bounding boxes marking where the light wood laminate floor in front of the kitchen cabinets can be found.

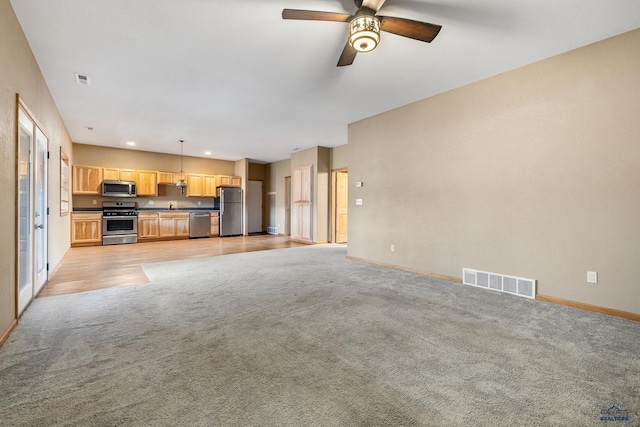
[38,235,304,298]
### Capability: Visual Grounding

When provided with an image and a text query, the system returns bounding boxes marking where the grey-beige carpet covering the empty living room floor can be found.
[0,245,640,426]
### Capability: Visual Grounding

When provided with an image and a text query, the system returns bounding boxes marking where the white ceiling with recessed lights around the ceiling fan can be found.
[11,0,640,162]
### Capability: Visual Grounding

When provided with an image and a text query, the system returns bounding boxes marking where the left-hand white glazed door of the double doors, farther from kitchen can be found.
[17,108,34,315]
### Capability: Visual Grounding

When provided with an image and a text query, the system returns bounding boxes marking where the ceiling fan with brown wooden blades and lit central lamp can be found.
[282,0,442,67]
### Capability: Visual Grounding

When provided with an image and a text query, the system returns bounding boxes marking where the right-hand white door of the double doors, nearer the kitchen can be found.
[33,127,49,295]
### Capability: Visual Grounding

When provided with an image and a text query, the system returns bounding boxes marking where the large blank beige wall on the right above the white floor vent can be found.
[348,30,640,313]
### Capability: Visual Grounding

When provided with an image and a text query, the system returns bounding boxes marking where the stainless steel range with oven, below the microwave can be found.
[102,202,138,246]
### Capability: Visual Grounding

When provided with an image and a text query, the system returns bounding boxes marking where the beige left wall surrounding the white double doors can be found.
[0,0,73,337]
